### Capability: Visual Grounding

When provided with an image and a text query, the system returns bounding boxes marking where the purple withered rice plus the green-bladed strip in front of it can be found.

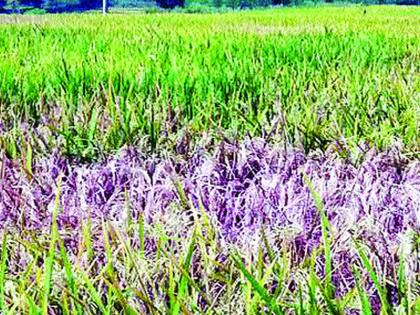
[0,140,420,314]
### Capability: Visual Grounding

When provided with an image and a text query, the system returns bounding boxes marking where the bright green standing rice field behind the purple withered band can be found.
[0,7,420,158]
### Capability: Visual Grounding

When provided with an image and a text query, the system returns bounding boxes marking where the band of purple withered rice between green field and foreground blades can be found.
[0,140,420,314]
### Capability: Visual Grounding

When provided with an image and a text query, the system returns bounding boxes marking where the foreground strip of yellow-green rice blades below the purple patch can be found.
[0,201,420,315]
